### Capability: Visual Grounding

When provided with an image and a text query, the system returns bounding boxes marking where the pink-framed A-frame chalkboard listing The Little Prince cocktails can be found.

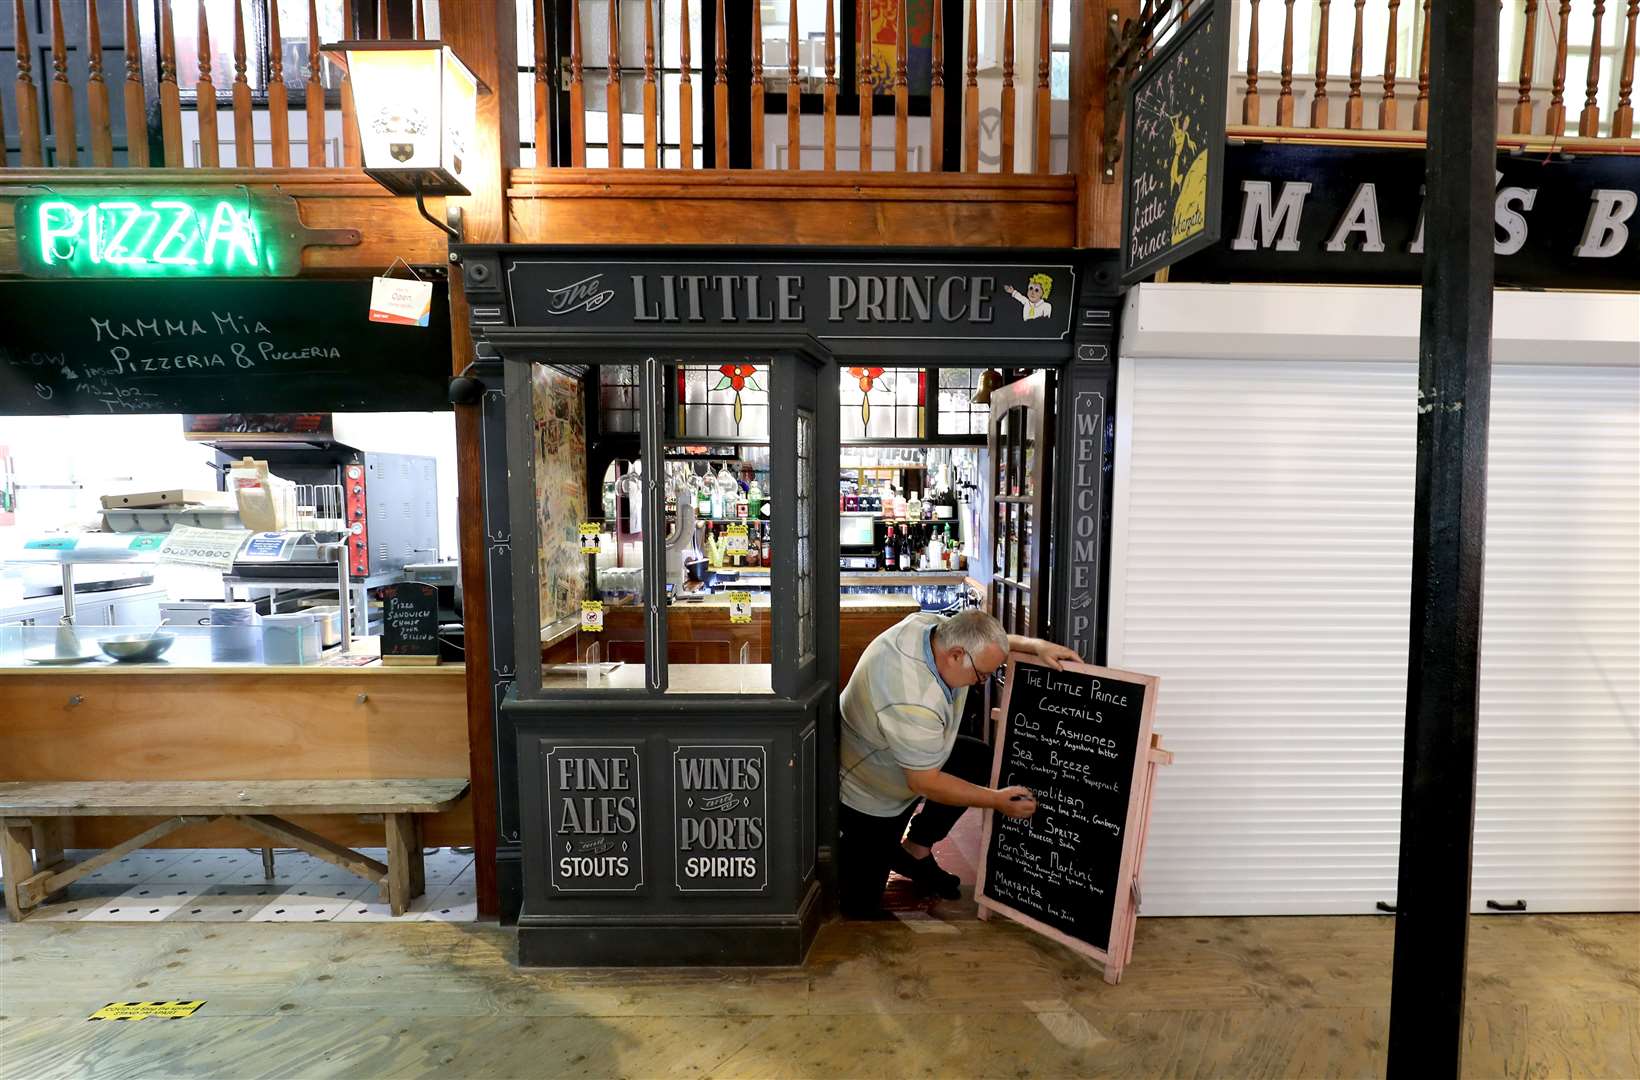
[974,654,1173,983]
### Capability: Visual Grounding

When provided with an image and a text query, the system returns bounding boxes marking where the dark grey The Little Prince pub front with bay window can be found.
[453,246,1117,965]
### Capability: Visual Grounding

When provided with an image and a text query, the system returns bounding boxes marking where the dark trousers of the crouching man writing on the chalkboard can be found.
[838,736,992,914]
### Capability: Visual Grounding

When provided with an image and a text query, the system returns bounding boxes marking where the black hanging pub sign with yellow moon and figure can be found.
[1122,0,1230,285]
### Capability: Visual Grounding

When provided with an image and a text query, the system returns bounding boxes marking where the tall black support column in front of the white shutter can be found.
[1389,0,1497,1077]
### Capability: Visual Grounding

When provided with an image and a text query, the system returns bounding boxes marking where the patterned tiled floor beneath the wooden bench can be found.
[0,847,479,923]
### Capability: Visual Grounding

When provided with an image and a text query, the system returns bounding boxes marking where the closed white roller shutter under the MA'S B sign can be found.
[1109,287,1640,914]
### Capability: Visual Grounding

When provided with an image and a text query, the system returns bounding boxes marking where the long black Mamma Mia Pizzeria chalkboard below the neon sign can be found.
[0,280,449,416]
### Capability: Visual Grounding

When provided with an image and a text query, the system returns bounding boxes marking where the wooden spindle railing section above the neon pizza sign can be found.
[0,0,425,169]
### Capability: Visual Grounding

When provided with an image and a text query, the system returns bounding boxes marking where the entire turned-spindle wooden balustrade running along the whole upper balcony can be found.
[9,0,1640,174]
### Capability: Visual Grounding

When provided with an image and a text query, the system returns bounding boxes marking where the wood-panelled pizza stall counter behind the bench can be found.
[0,628,472,847]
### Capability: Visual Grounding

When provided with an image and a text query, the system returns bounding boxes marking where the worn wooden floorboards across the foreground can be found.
[0,914,1640,1080]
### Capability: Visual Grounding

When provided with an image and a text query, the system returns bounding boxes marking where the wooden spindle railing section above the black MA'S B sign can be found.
[1230,0,1640,141]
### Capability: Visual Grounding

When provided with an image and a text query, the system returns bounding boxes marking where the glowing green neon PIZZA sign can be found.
[16,193,280,277]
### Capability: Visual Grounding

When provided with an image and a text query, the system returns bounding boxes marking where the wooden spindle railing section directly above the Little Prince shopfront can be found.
[528,0,1082,174]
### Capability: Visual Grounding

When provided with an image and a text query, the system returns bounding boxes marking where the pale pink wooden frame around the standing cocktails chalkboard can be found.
[974,652,1173,983]
